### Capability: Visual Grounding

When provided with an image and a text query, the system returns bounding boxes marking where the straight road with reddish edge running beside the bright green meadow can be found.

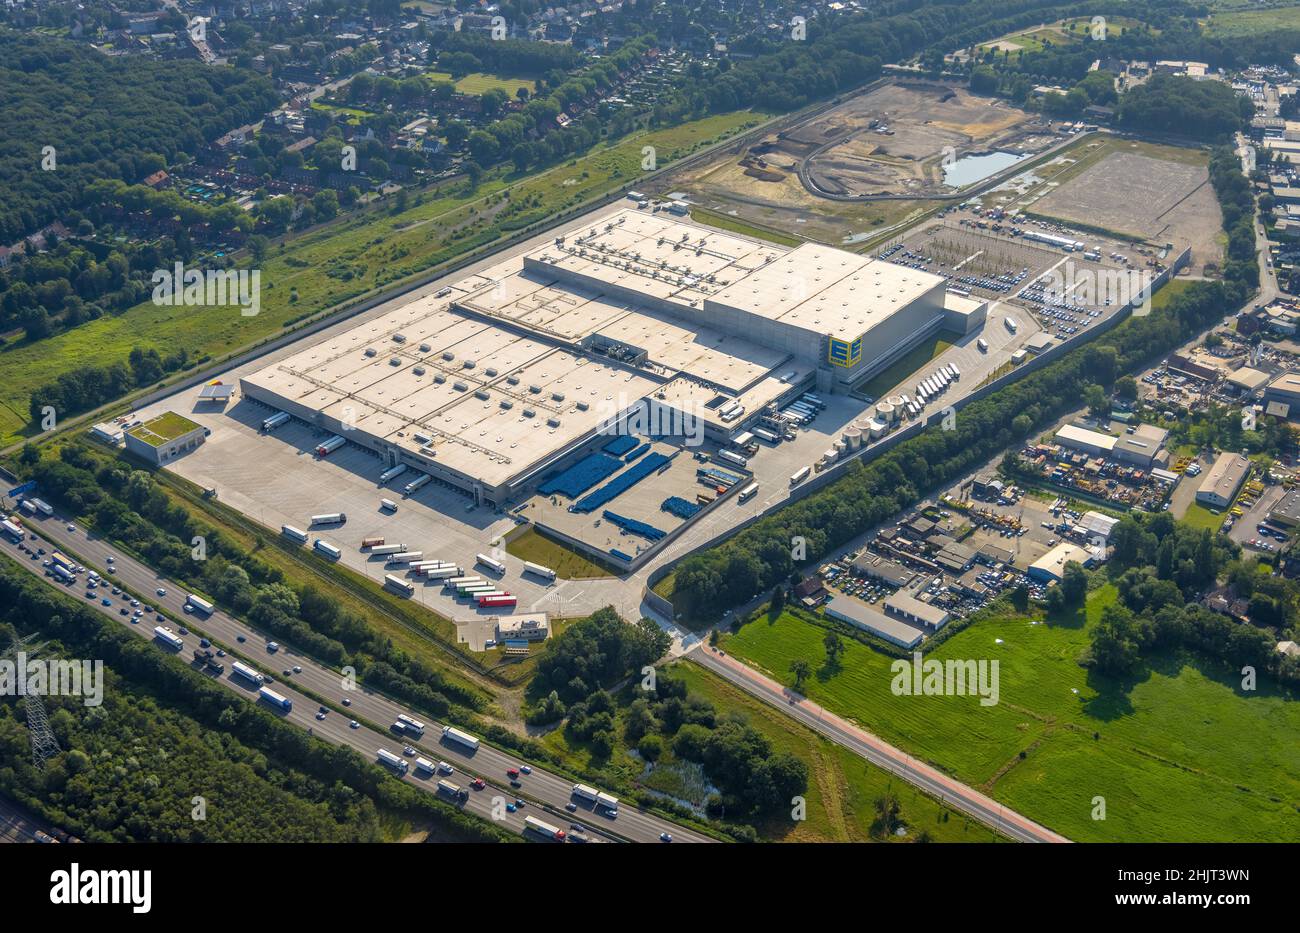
[686,646,1069,842]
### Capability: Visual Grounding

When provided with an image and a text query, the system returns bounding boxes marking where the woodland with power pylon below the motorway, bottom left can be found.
[0,559,515,842]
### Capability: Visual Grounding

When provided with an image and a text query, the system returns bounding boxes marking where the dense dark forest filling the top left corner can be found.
[0,30,277,246]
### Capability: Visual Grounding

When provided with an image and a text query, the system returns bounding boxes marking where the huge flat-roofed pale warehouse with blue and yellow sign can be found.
[241,209,985,504]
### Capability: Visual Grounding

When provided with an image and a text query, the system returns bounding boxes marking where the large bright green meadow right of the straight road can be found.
[723,586,1300,842]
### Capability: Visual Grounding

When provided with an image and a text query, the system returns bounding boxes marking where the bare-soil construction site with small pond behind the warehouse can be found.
[650,81,1063,246]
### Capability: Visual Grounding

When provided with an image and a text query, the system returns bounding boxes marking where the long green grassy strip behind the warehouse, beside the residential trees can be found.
[0,112,763,446]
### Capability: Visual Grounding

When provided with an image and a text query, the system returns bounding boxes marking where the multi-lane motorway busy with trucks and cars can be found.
[0,516,714,842]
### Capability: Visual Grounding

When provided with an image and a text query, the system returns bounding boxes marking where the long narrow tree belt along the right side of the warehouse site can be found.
[673,148,1258,620]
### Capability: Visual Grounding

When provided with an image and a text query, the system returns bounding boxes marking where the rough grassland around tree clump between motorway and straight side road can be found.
[541,661,1000,842]
